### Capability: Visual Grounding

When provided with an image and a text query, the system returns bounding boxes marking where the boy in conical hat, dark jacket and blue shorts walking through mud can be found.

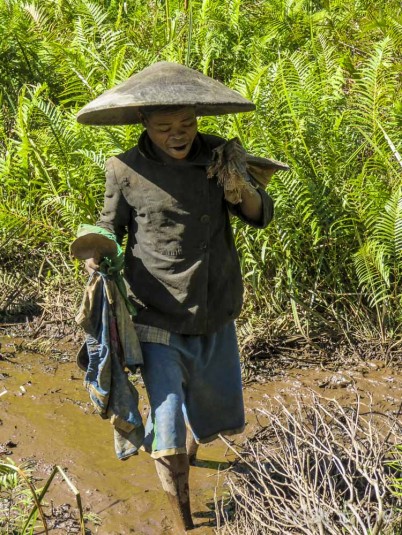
[78,62,280,533]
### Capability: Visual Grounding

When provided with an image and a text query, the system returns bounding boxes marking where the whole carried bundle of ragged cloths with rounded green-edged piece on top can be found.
[71,225,144,460]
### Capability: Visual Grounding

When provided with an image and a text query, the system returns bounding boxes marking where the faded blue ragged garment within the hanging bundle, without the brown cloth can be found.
[84,273,144,459]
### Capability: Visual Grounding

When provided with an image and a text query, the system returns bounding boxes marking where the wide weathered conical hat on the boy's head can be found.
[77,61,255,125]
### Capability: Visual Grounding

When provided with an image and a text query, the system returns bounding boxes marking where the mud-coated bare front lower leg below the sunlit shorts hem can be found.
[155,453,194,535]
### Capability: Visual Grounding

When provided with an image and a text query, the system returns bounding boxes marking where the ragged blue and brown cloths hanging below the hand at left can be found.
[76,271,144,460]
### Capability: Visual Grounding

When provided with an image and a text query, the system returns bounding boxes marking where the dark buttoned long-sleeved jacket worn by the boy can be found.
[97,132,273,334]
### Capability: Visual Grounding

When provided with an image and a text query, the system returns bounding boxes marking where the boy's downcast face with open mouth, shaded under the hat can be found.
[143,107,197,160]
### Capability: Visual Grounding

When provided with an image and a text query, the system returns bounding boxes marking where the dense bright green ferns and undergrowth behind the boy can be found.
[0,0,402,343]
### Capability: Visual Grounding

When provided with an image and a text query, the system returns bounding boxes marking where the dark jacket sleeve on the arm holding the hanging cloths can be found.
[96,157,131,244]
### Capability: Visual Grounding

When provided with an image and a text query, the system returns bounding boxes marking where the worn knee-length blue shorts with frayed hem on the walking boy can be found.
[141,322,245,458]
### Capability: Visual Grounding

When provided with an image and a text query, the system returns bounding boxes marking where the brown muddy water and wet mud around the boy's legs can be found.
[0,337,402,535]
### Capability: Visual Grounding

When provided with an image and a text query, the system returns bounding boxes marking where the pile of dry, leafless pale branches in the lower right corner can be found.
[219,394,402,535]
